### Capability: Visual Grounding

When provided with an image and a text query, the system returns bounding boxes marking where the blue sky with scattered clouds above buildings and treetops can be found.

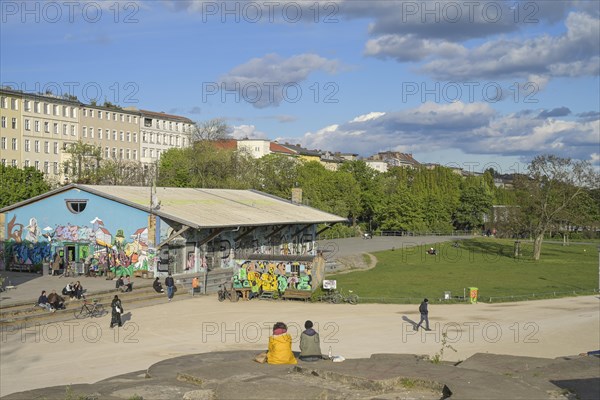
[0,0,600,173]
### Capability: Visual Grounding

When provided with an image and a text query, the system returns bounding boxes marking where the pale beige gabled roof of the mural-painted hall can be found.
[0,184,346,229]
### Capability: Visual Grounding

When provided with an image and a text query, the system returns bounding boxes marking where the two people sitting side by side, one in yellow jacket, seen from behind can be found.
[266,320,324,364]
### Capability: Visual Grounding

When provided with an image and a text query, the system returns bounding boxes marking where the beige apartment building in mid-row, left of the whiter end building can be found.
[80,104,140,161]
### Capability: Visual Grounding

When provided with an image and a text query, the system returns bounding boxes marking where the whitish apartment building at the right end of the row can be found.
[139,110,194,164]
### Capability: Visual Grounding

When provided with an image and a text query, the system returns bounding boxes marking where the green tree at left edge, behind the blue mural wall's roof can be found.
[0,164,50,208]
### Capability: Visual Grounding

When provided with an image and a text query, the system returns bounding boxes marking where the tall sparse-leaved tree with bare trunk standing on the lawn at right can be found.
[515,155,599,260]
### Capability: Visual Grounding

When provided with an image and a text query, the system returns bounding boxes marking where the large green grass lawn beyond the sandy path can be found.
[327,238,598,303]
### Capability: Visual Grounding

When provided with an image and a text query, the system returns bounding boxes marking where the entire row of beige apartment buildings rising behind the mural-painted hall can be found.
[0,88,194,183]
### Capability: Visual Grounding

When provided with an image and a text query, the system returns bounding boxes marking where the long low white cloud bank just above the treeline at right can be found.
[301,102,600,166]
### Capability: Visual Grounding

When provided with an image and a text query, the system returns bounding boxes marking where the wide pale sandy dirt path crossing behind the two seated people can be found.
[0,296,600,395]
